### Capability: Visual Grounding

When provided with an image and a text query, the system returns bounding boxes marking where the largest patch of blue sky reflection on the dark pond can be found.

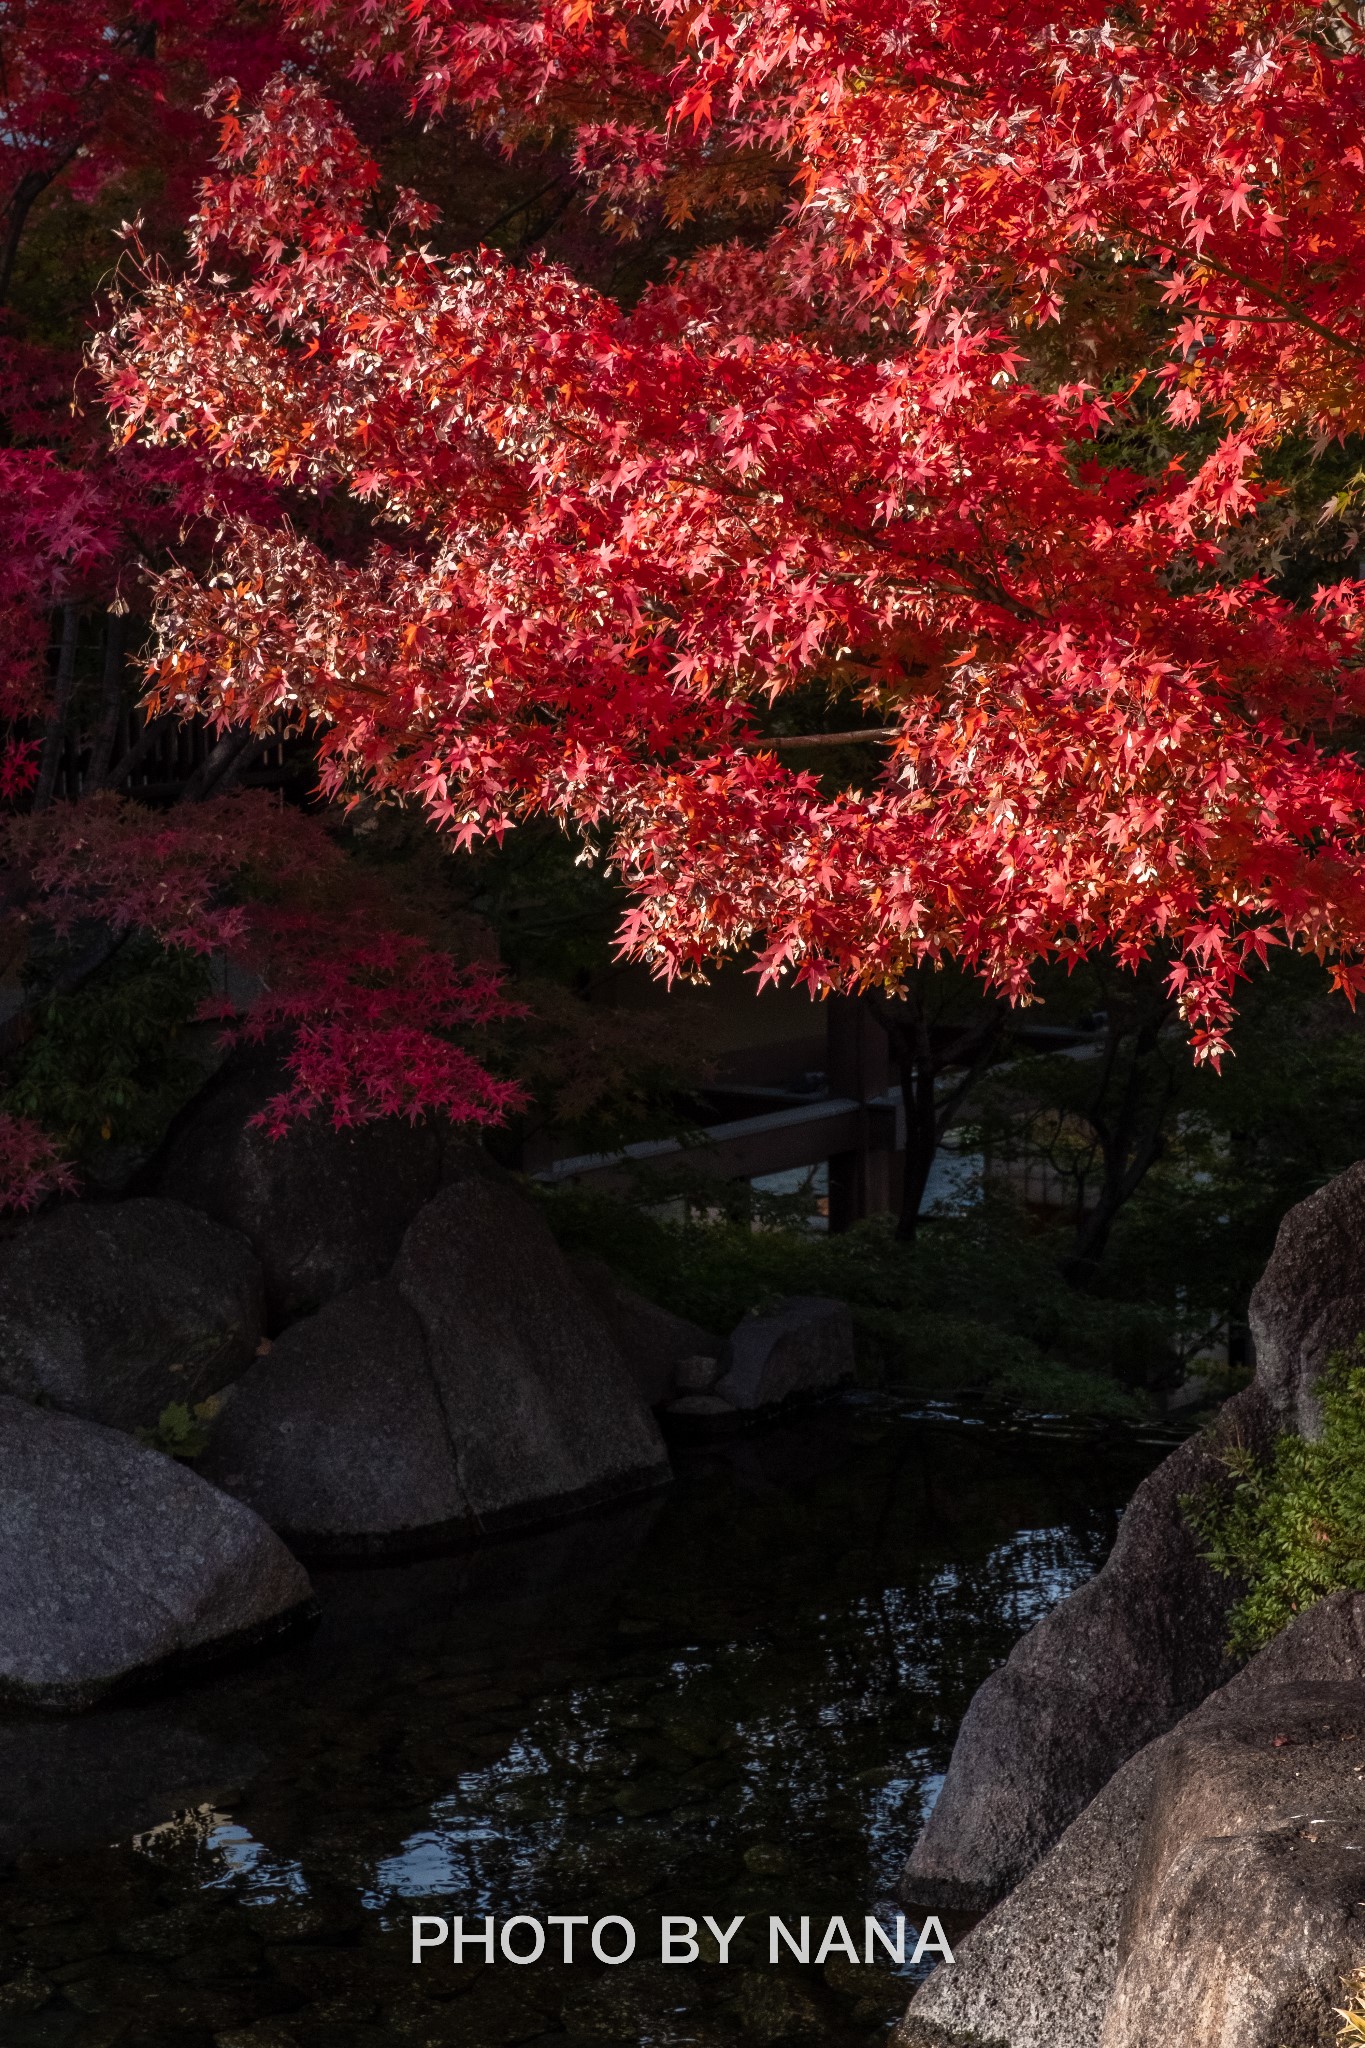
[366,1528,1097,1913]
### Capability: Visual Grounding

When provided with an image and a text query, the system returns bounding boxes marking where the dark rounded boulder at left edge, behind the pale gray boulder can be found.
[0,1198,264,1430]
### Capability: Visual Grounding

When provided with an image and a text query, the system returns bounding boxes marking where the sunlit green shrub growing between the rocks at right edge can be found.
[1185,1337,1365,1657]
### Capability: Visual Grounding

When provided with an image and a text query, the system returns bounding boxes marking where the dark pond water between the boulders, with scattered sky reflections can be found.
[0,1395,1166,2048]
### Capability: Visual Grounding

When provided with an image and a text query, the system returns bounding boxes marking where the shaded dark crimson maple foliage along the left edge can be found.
[0,0,520,1208]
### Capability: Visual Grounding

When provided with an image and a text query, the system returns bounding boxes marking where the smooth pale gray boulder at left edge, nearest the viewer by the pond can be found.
[0,1395,311,1708]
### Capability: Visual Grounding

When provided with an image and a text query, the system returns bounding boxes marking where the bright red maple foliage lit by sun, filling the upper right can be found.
[100,0,1365,1089]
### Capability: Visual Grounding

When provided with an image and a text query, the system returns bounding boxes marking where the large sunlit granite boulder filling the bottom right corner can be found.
[894,1593,1365,2048]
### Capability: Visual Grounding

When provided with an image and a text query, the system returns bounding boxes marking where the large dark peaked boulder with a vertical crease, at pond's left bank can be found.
[205,1171,669,1556]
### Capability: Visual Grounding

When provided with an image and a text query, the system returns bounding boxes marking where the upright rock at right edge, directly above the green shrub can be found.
[1250,1159,1365,1436]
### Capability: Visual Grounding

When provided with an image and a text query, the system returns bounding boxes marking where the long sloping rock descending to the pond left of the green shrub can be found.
[902,1389,1265,1911]
